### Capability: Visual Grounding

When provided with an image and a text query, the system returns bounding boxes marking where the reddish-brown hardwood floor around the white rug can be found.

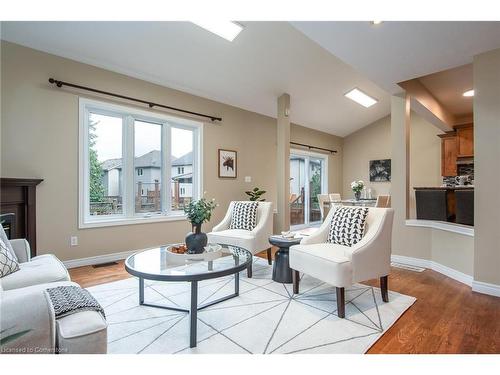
[69,253,500,353]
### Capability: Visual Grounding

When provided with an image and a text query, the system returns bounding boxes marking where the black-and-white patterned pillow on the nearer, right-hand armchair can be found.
[327,207,368,246]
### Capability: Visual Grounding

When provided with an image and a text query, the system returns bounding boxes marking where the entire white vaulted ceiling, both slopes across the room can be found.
[1,22,500,136]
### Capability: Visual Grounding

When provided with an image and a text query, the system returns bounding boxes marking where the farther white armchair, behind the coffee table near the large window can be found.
[207,201,273,277]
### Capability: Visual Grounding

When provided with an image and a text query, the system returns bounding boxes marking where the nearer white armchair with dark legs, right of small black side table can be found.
[290,207,394,318]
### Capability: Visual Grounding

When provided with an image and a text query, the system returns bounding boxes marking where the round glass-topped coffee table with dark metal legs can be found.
[125,245,252,348]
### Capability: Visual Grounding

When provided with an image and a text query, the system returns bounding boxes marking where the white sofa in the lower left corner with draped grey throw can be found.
[0,239,107,354]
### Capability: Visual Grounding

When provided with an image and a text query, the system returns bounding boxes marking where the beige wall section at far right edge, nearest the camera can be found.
[473,49,500,285]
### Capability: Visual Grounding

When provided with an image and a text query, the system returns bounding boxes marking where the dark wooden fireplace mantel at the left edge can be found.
[0,177,43,257]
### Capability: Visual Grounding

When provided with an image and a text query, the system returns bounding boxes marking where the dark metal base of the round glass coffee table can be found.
[139,272,240,348]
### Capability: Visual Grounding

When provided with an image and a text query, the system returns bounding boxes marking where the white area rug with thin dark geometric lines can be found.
[88,258,416,354]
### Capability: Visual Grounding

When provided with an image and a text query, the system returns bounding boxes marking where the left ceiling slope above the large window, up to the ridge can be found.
[2,22,390,136]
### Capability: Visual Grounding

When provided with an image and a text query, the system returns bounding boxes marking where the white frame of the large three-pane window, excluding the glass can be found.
[78,97,203,229]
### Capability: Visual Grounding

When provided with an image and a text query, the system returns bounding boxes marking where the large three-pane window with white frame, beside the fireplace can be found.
[79,99,202,227]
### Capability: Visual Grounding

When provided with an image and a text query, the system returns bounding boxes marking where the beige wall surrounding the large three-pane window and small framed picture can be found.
[1,42,334,260]
